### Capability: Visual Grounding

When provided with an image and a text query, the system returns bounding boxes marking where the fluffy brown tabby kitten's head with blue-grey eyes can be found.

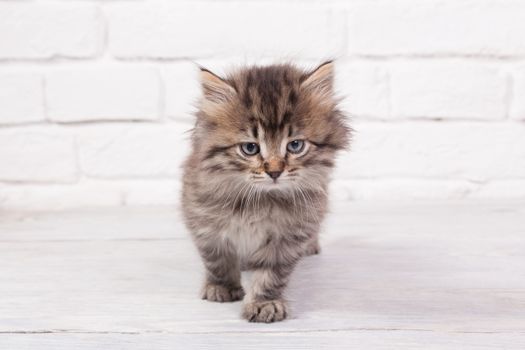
[193,62,350,196]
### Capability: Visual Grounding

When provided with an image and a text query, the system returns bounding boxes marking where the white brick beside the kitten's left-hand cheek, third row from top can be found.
[76,123,192,178]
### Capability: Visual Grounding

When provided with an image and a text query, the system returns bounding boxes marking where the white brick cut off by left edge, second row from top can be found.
[0,72,45,124]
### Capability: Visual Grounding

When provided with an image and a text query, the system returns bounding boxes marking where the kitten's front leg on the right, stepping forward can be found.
[242,261,295,322]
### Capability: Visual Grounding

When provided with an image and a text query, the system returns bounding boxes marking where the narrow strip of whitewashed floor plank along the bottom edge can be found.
[0,330,525,350]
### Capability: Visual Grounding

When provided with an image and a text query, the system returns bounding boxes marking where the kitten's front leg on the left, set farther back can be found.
[197,238,244,302]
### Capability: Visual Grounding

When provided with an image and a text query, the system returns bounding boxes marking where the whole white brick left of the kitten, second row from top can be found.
[46,67,160,122]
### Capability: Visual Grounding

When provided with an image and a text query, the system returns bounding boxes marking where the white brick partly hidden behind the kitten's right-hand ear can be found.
[336,63,389,119]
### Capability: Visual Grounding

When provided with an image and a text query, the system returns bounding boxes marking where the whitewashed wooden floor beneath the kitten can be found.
[0,202,525,350]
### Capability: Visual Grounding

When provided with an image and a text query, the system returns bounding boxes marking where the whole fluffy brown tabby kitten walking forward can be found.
[182,62,350,322]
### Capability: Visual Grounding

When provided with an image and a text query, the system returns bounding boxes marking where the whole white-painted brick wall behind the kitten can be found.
[0,0,525,209]
